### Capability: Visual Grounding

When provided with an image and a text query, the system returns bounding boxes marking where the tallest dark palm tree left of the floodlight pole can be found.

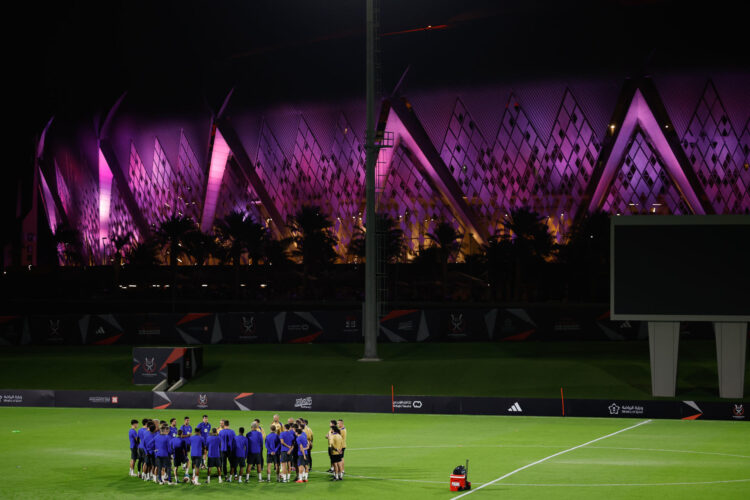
[288,205,338,289]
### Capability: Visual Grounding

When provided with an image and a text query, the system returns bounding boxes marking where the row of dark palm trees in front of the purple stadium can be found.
[55,206,609,299]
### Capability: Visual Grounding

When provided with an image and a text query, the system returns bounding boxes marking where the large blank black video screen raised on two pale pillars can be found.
[610,215,750,321]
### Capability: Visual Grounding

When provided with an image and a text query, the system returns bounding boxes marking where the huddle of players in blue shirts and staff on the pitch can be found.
[128,415,346,485]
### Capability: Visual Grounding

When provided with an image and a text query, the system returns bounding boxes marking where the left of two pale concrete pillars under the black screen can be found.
[648,321,680,397]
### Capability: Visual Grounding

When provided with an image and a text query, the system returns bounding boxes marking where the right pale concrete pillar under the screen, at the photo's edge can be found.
[714,322,747,399]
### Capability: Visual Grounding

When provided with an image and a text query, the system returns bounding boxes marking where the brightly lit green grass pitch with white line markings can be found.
[0,408,750,500]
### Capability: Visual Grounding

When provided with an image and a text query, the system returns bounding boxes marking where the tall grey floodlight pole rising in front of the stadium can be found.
[362,0,379,361]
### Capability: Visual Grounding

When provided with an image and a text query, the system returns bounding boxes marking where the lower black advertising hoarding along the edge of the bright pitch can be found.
[0,389,748,422]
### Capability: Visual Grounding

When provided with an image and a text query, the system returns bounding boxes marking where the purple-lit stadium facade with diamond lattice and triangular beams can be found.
[32,74,750,262]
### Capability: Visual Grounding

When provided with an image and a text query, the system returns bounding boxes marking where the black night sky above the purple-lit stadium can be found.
[3,0,749,223]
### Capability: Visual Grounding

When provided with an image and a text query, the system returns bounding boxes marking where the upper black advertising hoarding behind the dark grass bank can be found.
[10,305,713,346]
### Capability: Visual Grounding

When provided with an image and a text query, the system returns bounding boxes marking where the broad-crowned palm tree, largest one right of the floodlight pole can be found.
[502,207,554,299]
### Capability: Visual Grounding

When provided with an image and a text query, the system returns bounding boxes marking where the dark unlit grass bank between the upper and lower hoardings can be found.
[0,340,750,400]
